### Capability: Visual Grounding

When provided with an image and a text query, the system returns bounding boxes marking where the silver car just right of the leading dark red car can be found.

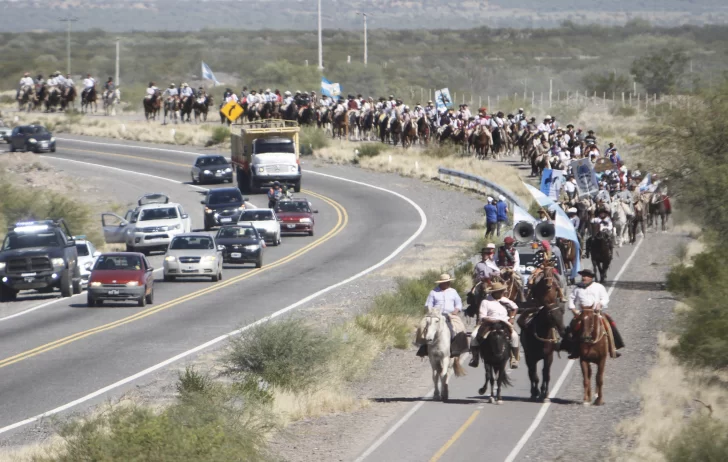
[164,233,223,282]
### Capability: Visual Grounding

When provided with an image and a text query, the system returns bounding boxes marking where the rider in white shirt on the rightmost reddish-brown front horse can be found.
[561,269,624,359]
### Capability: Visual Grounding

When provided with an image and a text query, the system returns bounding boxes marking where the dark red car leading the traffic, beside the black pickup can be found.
[86,252,154,307]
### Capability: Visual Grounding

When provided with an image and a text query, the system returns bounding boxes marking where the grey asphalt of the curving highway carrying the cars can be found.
[0,139,424,438]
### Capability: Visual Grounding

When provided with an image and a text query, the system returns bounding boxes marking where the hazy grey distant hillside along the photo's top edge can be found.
[0,0,728,32]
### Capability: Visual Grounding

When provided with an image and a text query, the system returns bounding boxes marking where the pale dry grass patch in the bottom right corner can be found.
[610,330,728,462]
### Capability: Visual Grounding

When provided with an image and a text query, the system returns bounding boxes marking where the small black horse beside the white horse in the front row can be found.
[478,321,515,404]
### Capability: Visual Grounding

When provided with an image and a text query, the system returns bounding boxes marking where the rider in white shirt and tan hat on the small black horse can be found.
[469,282,519,369]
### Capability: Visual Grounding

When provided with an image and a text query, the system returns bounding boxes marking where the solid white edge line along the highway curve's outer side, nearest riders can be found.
[0,172,427,434]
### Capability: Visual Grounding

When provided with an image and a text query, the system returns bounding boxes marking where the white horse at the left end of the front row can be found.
[420,308,465,401]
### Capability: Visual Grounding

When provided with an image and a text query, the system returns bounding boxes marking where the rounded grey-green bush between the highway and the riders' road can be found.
[226,319,338,392]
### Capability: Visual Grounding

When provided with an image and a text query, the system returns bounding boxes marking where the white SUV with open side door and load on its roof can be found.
[101,193,192,253]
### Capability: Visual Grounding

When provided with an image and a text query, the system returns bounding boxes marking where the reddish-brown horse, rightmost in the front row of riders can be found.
[576,307,610,406]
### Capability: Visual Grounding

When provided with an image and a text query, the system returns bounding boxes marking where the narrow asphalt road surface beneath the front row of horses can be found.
[357,233,674,462]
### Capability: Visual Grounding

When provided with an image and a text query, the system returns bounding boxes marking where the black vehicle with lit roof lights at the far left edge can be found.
[0,219,82,301]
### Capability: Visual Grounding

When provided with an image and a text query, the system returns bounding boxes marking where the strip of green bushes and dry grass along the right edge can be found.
[613,75,728,462]
